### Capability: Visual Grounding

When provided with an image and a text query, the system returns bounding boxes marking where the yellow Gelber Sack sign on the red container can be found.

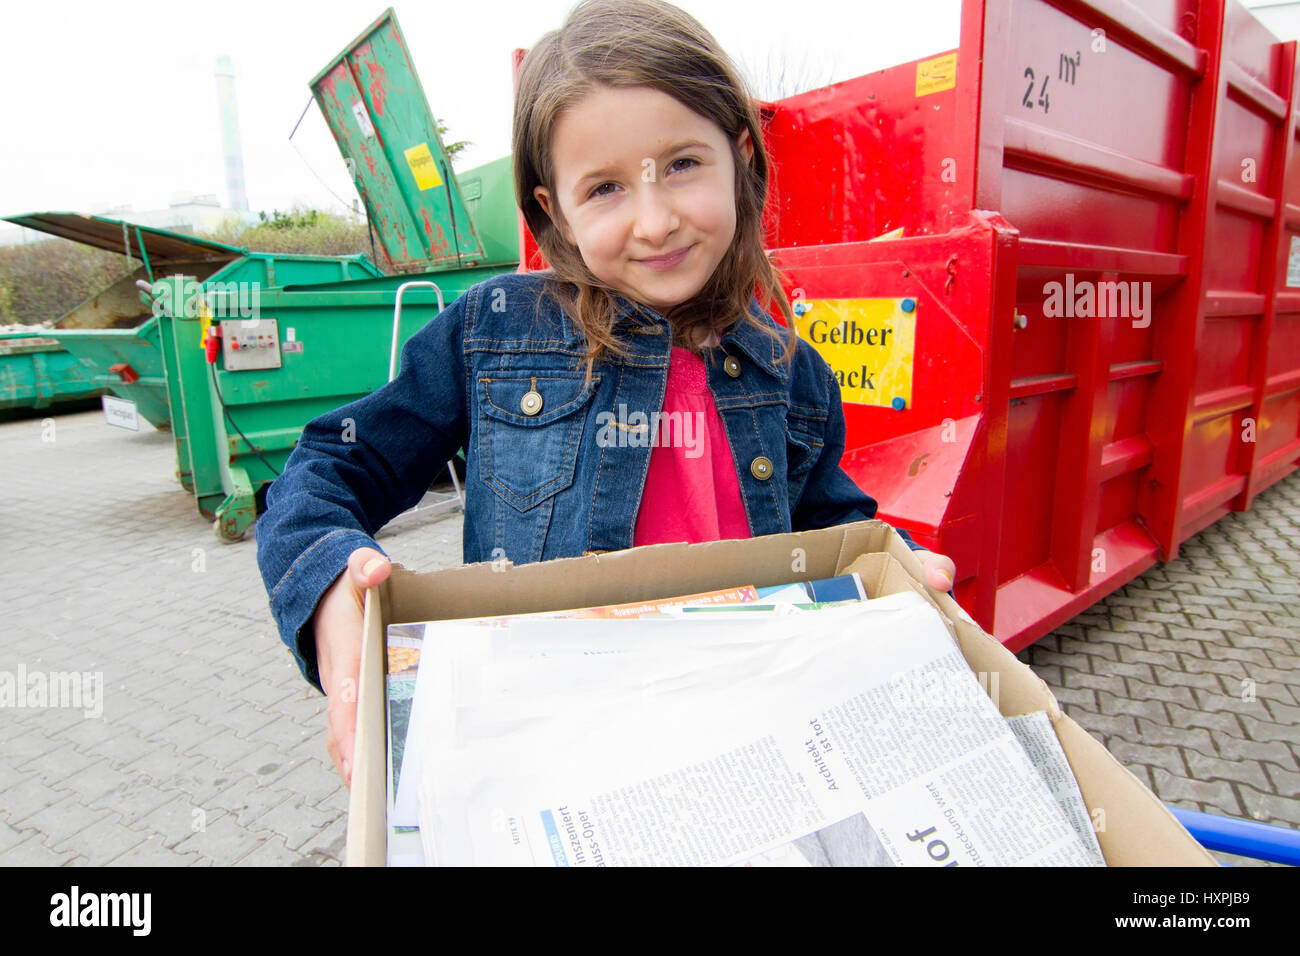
[794,298,917,408]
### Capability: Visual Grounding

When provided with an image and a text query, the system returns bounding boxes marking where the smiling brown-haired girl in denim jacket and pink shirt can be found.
[257,0,954,783]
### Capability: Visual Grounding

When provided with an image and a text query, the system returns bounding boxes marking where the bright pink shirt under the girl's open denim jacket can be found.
[632,347,750,546]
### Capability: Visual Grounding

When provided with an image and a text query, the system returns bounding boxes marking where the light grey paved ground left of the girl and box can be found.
[0,411,460,866]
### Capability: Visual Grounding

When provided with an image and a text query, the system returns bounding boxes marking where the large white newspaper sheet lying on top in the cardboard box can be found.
[403,592,1100,866]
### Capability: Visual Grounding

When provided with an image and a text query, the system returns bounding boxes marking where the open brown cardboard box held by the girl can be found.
[347,522,1217,866]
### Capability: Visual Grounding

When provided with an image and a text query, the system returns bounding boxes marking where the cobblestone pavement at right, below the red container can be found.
[1019,472,1300,865]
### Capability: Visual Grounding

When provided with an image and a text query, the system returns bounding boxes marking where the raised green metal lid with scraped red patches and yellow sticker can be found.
[311,8,486,272]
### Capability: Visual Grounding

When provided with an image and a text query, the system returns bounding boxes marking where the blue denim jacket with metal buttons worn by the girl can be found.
[256,273,919,687]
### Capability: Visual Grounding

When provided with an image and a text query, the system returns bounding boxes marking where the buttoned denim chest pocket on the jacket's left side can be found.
[476,369,599,511]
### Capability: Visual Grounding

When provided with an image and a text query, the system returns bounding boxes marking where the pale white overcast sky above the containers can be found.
[0,0,961,234]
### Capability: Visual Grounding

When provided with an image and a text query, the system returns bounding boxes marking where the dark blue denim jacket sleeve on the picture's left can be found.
[255,289,477,688]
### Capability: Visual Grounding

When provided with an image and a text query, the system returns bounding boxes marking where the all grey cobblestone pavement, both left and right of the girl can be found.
[0,411,1300,866]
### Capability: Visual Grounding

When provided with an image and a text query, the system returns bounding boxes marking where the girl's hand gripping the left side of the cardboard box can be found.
[309,548,393,787]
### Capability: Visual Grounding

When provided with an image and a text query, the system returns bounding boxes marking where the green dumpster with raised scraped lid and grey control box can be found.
[161,10,519,541]
